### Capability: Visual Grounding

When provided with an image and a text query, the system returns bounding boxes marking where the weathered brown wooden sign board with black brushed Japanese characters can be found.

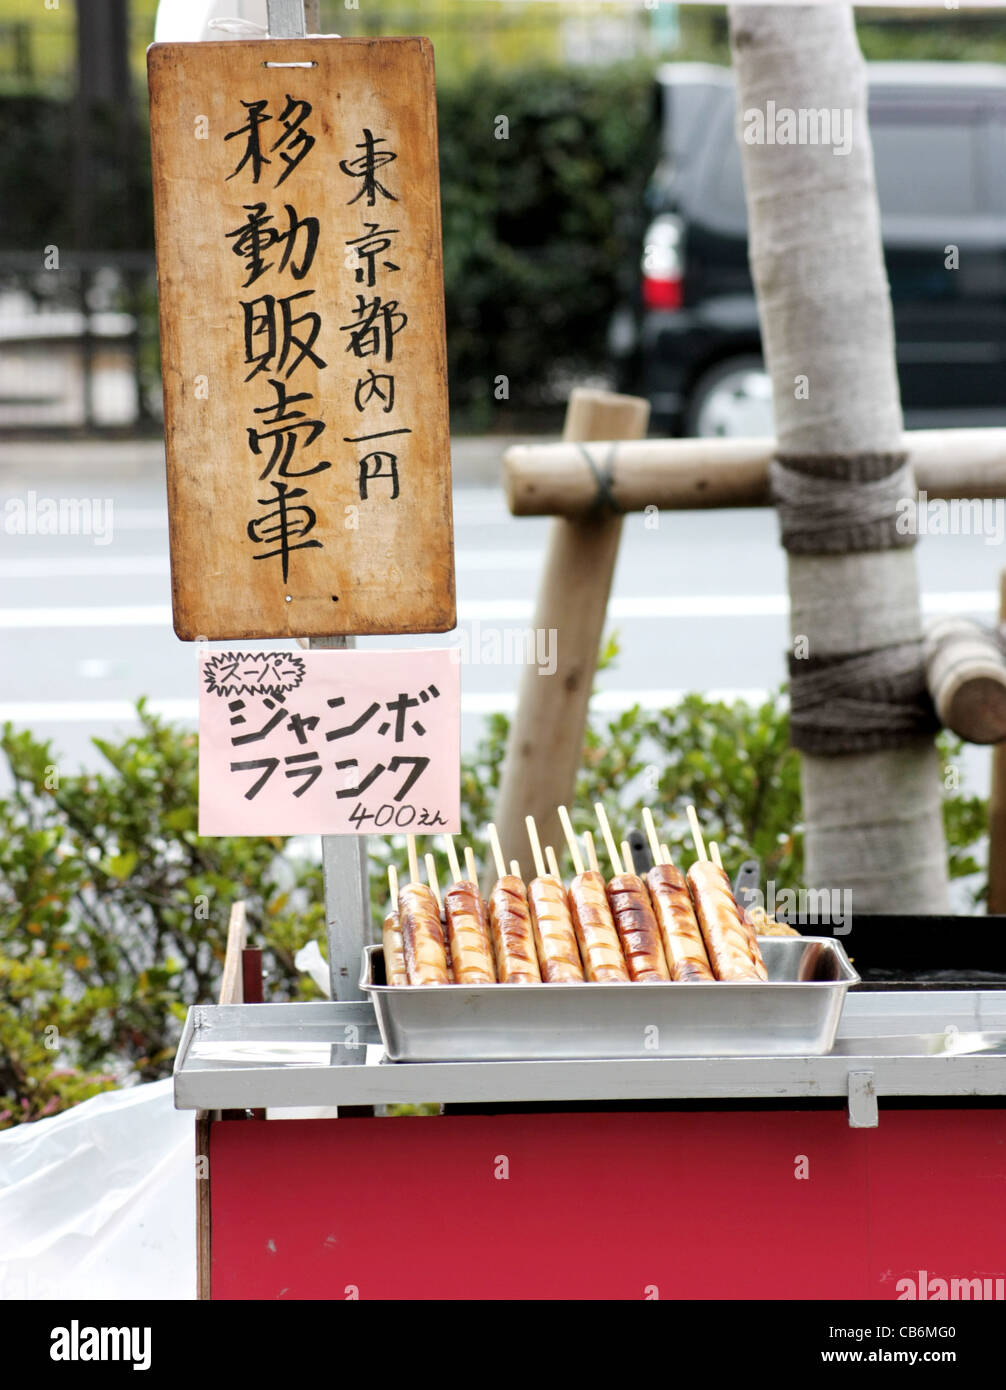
[147,39,456,641]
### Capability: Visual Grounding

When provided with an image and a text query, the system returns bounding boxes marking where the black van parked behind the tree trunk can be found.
[609,63,1006,435]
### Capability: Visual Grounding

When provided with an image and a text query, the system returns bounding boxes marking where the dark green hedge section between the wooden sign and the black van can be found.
[439,67,657,425]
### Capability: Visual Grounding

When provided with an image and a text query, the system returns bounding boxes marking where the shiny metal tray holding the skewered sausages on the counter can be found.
[360,937,859,1062]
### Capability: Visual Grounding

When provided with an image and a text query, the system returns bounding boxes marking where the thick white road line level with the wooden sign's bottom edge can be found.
[0,589,999,628]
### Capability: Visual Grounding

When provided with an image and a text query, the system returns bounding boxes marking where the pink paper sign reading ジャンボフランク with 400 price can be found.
[199,648,461,835]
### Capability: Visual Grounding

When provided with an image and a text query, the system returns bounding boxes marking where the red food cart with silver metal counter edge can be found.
[175,895,1006,1300]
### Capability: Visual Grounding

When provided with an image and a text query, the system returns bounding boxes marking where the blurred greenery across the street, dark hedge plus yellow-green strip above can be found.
[0,0,1006,431]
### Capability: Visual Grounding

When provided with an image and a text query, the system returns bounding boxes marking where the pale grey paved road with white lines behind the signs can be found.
[0,439,1003,811]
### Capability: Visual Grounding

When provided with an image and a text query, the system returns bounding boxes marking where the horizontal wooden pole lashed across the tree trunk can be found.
[503,428,1006,517]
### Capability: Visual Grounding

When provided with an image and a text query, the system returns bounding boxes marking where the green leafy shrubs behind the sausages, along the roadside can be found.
[0,642,988,1127]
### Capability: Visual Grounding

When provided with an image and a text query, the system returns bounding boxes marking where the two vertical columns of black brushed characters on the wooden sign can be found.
[224,93,411,582]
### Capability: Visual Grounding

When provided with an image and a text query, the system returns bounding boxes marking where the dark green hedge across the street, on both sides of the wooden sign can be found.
[0,65,656,428]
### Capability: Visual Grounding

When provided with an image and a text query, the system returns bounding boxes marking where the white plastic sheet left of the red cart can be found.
[0,1079,196,1300]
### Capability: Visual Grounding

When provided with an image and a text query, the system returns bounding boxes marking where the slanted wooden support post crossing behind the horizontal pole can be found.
[496,389,649,858]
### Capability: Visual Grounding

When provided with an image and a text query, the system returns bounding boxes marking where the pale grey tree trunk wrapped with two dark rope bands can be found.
[729,6,946,913]
